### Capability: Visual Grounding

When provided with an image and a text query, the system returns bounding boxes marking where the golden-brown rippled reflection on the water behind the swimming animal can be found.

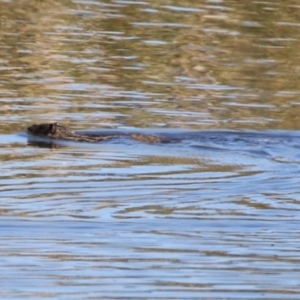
[0,1,299,132]
